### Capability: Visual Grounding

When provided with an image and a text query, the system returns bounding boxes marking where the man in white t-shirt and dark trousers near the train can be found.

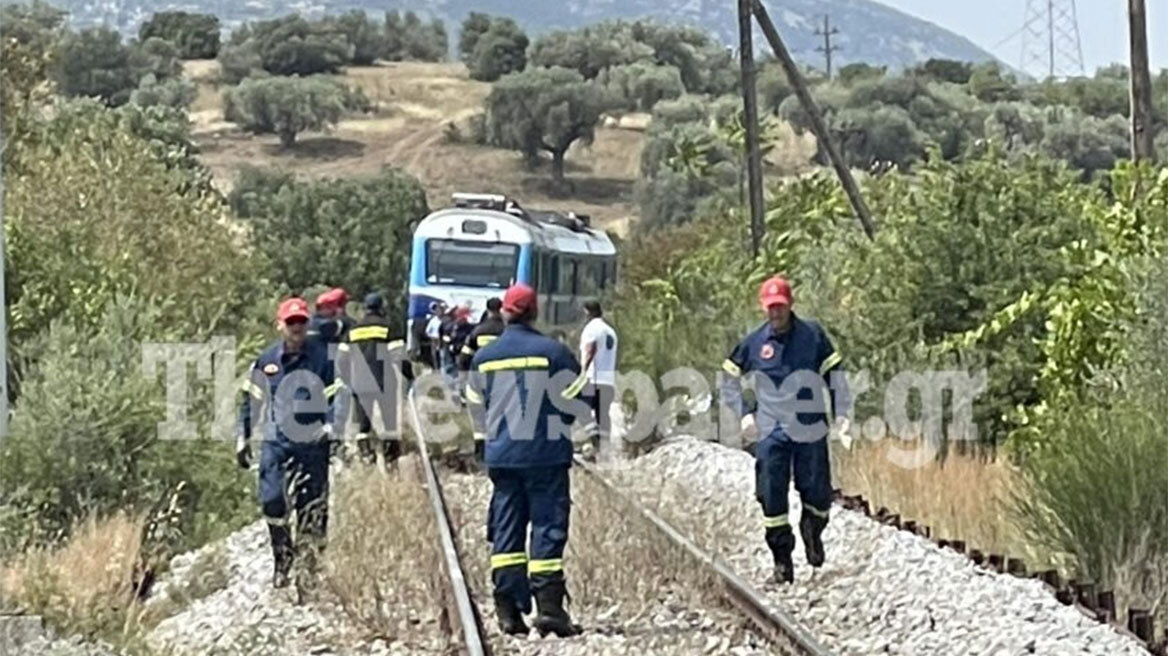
[580,301,617,452]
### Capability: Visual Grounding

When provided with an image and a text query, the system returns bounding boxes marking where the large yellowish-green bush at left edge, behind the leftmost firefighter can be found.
[5,102,265,354]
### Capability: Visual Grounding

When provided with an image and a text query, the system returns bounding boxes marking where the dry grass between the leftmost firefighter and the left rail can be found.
[324,456,446,643]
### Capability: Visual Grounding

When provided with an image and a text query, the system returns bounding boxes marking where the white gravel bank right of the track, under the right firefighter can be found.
[613,439,1148,656]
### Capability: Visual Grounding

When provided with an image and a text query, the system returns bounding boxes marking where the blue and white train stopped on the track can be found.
[406,194,617,348]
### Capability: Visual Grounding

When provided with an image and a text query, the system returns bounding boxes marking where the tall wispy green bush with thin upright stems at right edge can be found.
[1014,254,1168,608]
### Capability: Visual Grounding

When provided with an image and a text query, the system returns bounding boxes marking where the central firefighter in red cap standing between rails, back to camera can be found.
[466,285,588,637]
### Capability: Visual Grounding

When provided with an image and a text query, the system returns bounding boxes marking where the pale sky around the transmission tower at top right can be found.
[877,0,1168,72]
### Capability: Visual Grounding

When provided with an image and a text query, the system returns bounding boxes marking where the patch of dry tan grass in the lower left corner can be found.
[0,514,146,642]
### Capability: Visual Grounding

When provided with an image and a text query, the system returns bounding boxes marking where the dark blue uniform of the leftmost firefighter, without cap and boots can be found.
[238,340,342,559]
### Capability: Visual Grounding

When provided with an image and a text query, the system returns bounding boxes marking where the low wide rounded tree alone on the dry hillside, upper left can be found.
[223,77,349,148]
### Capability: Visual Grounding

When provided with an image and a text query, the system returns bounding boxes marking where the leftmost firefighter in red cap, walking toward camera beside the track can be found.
[236,298,343,589]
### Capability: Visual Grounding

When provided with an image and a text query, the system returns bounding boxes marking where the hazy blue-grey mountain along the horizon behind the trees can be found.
[50,0,994,69]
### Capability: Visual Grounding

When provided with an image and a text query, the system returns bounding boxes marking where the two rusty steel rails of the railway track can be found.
[408,391,832,656]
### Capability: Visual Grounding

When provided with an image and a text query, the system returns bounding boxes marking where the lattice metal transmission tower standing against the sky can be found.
[1021,0,1086,77]
